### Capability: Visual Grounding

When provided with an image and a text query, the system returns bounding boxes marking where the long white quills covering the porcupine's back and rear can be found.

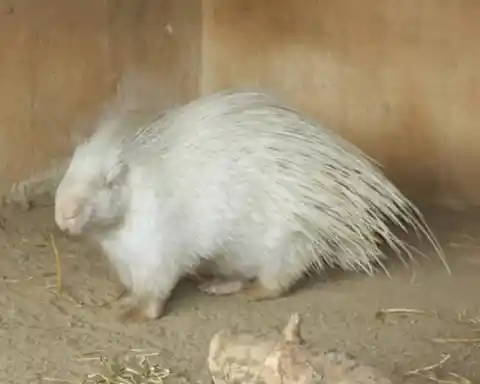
[118,91,449,274]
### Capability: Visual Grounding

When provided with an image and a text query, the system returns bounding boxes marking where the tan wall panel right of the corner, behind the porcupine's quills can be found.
[202,0,480,208]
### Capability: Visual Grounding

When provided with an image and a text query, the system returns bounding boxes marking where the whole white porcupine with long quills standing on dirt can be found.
[55,91,448,319]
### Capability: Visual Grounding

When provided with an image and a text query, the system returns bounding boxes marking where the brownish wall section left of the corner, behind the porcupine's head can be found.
[0,0,201,200]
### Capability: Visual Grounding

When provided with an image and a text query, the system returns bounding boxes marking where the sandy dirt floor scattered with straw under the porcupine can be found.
[0,200,480,384]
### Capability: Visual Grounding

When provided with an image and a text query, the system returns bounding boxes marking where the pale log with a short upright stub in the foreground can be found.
[208,314,392,384]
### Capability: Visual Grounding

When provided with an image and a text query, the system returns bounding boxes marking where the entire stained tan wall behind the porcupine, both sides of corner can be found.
[0,0,480,210]
